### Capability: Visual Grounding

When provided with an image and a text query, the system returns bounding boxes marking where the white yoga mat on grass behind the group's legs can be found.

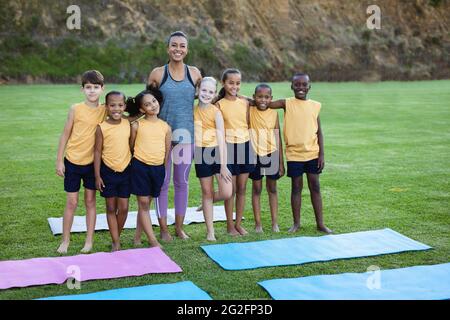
[47,206,236,235]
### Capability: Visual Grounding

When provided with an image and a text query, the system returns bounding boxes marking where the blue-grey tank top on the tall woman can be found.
[159,64,195,143]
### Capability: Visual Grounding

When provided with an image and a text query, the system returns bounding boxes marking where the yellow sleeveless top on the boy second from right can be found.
[250,107,278,157]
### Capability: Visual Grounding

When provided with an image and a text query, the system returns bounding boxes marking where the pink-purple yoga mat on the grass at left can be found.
[0,247,182,289]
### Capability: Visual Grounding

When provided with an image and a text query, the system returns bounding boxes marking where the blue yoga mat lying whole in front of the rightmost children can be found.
[201,229,431,270]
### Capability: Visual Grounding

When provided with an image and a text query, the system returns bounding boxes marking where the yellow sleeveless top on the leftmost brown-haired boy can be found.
[66,102,106,166]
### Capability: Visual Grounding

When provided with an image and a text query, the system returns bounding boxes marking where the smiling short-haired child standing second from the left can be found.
[94,91,131,251]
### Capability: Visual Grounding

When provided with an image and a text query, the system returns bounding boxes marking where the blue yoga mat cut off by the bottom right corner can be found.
[258,263,450,300]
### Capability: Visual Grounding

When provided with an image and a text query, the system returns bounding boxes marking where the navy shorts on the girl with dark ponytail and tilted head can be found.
[131,158,166,198]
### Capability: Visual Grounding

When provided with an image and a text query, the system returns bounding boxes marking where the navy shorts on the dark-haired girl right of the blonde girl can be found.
[227,141,256,176]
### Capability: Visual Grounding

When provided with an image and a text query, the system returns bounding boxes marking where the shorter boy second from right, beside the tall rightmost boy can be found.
[250,84,284,233]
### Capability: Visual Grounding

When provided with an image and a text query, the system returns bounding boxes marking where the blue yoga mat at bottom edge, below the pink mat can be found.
[38,281,212,300]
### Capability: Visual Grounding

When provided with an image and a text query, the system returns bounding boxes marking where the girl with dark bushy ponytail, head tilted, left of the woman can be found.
[127,88,172,247]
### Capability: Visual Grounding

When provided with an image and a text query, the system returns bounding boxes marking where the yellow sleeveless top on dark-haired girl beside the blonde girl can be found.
[218,98,250,143]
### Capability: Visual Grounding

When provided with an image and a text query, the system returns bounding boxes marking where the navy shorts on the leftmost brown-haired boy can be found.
[64,158,96,192]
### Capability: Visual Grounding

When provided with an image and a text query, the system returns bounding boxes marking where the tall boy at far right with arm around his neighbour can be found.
[269,73,332,233]
